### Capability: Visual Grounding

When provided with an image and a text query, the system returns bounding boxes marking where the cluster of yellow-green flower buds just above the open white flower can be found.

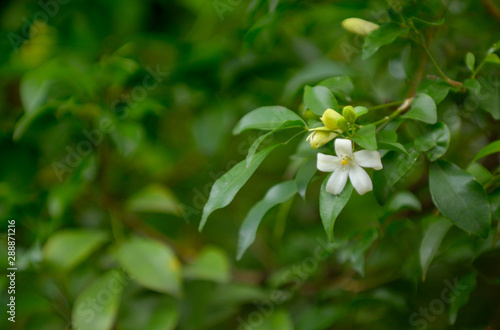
[307,105,357,149]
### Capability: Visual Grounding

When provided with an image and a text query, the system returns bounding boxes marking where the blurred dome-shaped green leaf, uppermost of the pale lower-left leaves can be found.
[126,184,184,217]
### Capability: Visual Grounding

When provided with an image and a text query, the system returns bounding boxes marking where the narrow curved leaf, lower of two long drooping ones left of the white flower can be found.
[236,181,297,260]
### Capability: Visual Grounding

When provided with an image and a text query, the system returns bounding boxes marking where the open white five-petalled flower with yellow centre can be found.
[317,139,382,195]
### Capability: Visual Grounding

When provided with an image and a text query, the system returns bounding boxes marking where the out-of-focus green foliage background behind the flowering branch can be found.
[0,0,500,330]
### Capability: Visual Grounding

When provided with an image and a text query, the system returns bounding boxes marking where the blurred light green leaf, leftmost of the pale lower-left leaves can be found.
[43,229,107,271]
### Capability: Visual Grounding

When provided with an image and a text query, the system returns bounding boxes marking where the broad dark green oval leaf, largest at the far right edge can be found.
[429,160,491,238]
